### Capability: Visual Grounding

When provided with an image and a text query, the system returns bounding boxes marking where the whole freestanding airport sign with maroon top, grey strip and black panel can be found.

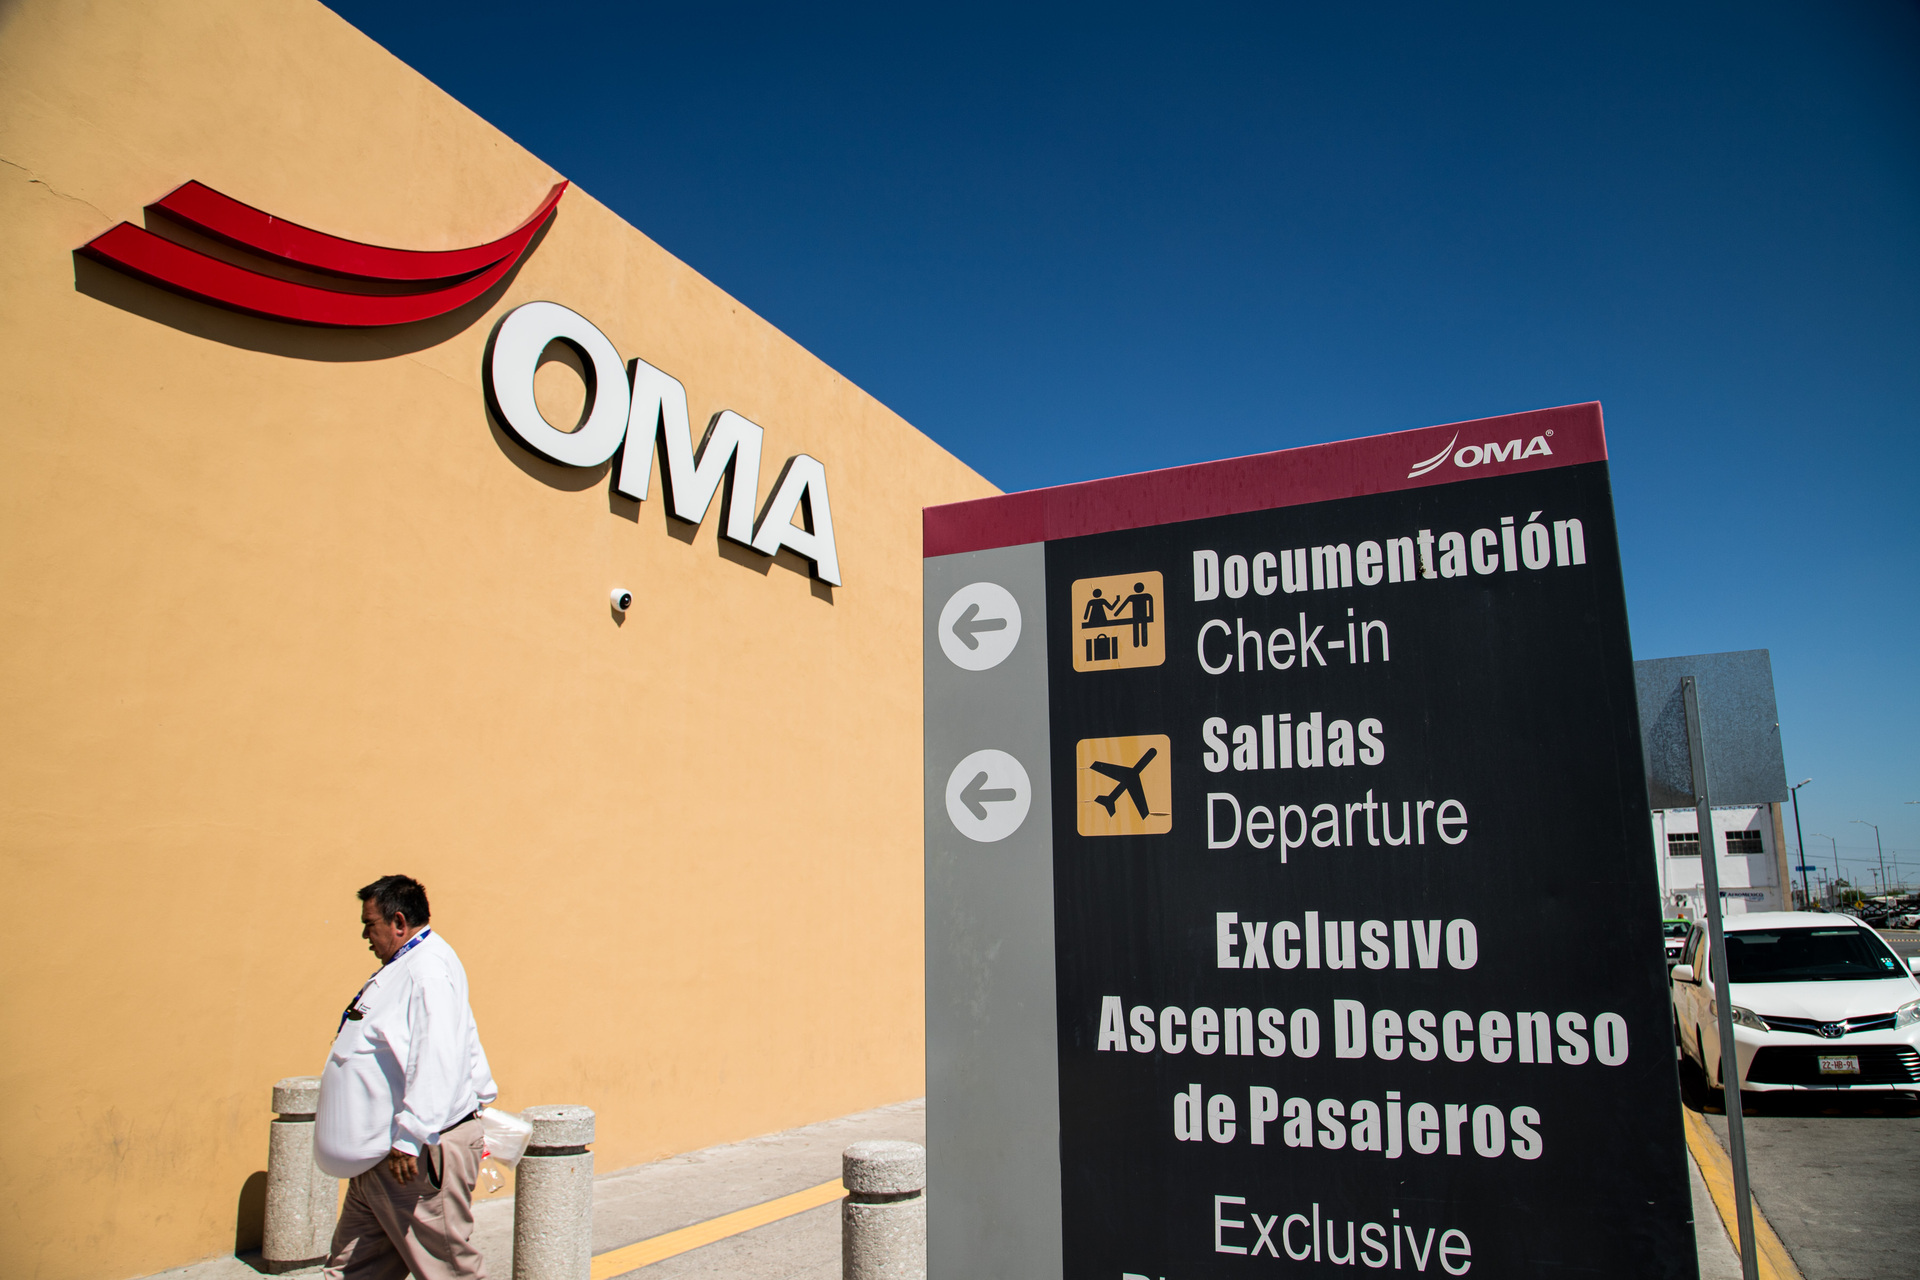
[922,405,1689,1280]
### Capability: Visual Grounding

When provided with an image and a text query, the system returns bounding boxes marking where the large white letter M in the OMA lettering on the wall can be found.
[614,361,766,547]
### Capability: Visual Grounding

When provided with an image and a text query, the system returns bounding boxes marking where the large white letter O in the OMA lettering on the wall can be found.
[486,301,630,466]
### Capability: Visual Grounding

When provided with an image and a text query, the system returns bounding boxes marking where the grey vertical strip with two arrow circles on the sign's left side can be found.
[924,543,1062,1280]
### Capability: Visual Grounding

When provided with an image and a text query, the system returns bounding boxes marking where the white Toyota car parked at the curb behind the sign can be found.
[1672,912,1920,1092]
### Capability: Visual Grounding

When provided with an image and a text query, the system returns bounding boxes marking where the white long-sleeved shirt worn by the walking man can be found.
[313,929,499,1178]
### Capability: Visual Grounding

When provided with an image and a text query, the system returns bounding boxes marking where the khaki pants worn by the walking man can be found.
[324,1121,486,1280]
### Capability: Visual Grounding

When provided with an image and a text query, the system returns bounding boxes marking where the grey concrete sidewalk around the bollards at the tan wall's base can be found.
[150,1100,927,1280]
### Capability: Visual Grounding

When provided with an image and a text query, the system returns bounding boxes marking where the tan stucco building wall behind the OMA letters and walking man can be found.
[0,0,993,1278]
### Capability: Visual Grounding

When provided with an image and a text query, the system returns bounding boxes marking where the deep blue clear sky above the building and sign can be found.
[332,0,1920,883]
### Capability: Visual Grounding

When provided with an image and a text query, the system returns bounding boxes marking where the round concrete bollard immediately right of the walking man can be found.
[513,1107,593,1280]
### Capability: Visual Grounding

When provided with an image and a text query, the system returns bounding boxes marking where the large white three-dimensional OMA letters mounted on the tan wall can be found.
[486,301,841,587]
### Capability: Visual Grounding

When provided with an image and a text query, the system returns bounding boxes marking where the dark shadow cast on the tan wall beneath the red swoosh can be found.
[73,219,553,363]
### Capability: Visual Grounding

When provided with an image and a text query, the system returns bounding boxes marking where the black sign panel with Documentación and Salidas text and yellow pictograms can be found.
[1044,461,1695,1280]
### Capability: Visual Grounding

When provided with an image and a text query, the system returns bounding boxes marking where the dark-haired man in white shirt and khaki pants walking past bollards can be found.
[313,875,499,1280]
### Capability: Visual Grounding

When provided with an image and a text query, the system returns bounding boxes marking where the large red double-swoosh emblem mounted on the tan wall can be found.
[81,182,566,328]
